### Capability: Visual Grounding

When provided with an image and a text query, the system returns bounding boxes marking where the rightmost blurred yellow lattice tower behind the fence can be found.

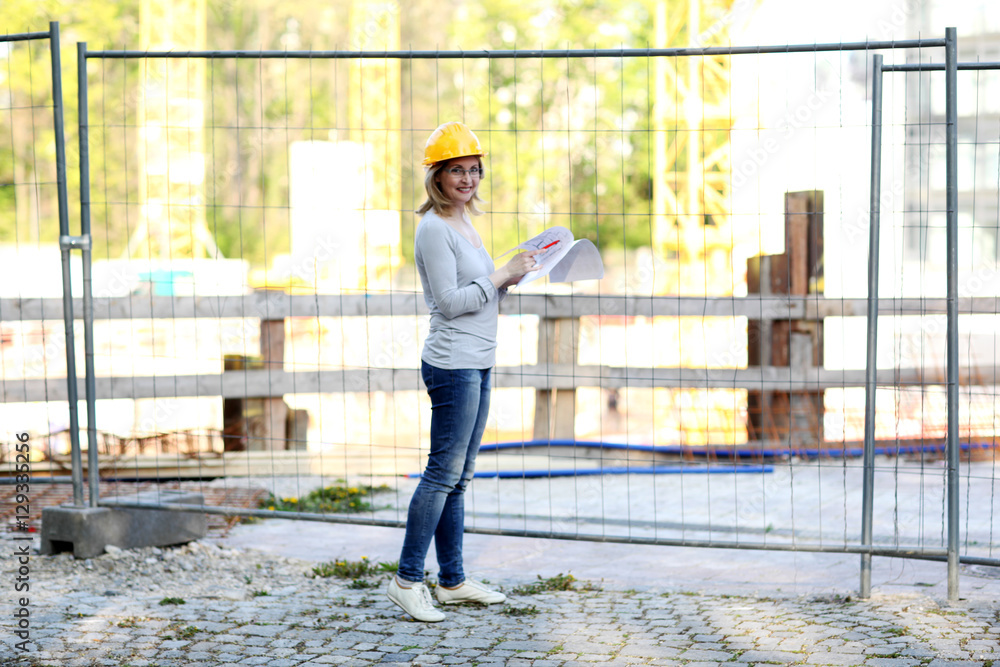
[653,0,735,295]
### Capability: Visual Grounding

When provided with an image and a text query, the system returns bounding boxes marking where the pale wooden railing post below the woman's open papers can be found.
[533,317,580,440]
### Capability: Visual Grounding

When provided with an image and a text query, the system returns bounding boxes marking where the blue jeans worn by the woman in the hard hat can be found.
[399,362,490,587]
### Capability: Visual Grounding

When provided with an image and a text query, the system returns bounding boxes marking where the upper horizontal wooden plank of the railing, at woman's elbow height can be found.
[7,293,1000,322]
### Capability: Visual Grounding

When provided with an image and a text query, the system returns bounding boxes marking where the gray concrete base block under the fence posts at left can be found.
[41,491,208,558]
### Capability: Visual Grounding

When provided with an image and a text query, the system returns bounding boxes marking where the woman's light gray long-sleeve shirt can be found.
[413,210,506,369]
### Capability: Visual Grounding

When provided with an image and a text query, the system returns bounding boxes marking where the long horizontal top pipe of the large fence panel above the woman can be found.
[87,38,945,60]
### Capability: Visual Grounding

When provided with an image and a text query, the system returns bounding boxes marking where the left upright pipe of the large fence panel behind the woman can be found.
[76,42,101,507]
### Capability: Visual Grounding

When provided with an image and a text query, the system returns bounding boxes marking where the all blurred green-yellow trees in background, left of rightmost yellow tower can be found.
[0,0,664,266]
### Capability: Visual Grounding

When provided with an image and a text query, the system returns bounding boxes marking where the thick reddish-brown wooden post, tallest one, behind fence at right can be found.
[747,190,824,446]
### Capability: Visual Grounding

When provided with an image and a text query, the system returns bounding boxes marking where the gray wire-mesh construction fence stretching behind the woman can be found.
[0,26,1000,598]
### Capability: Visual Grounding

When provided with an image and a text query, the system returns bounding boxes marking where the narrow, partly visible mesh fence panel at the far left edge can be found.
[0,23,81,516]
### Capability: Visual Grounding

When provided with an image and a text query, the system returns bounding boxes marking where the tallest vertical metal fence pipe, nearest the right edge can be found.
[944,28,959,601]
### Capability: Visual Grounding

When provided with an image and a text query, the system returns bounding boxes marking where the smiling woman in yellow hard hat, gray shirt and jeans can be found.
[386,123,540,622]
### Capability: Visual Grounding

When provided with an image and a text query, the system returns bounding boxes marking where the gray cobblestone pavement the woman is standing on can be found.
[0,541,1000,667]
